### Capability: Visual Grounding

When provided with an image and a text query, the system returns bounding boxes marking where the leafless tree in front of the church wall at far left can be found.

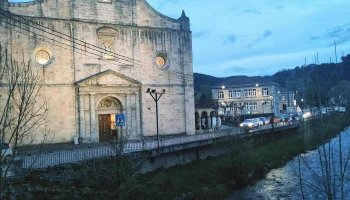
[0,44,49,198]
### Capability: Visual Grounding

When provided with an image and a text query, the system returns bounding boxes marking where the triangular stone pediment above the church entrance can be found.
[75,70,141,86]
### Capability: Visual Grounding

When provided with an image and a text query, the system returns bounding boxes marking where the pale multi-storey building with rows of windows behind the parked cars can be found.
[212,77,294,117]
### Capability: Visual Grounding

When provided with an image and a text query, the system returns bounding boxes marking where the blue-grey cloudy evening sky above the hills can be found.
[10,0,350,77]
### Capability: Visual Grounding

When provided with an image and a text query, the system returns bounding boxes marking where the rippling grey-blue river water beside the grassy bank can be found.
[225,128,350,200]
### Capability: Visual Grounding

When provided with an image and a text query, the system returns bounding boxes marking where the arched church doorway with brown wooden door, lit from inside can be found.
[97,97,123,142]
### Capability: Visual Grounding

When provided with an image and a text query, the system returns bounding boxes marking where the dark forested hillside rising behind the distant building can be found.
[194,54,350,106]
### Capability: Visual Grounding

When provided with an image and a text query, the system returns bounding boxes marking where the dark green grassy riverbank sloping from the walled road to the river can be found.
[3,112,350,200]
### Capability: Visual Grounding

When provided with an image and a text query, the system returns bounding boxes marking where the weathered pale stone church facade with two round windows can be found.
[0,0,195,143]
